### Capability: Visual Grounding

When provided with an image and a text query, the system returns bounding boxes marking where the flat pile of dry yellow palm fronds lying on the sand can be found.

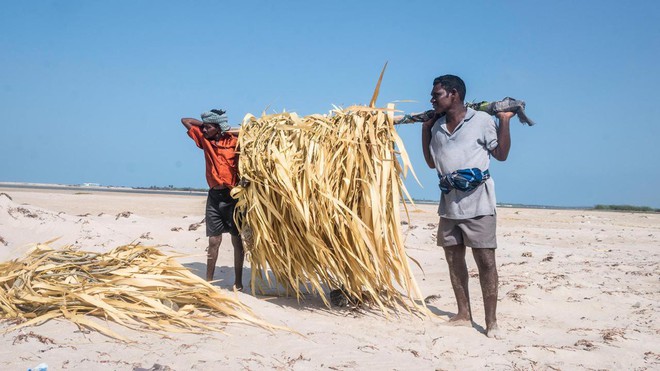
[0,244,273,341]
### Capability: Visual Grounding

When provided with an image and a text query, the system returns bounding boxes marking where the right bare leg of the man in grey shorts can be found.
[472,249,501,339]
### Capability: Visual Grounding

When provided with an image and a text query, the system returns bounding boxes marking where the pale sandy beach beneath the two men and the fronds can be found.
[0,187,660,370]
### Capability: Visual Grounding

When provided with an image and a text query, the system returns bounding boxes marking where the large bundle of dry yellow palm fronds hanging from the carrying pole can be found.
[232,93,423,311]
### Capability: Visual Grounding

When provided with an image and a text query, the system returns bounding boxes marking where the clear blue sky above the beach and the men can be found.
[0,0,660,208]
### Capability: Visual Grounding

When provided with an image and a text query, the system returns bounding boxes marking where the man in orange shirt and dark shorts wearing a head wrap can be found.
[181,109,244,291]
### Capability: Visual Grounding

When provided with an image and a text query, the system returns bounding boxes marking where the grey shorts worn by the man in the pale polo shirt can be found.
[438,215,497,249]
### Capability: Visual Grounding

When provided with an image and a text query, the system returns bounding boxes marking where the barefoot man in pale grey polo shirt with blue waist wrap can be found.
[422,75,514,338]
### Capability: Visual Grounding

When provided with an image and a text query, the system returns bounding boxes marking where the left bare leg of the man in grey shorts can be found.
[444,244,472,326]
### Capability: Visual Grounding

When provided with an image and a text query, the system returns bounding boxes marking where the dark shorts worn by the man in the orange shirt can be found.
[206,188,238,237]
